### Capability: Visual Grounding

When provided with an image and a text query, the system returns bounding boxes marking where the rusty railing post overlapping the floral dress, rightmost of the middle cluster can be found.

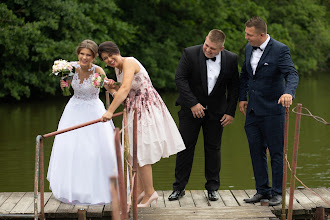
[133,109,138,220]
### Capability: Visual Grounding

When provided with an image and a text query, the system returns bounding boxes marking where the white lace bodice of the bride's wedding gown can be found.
[71,62,100,100]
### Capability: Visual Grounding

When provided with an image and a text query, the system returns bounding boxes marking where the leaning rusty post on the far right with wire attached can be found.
[288,103,302,220]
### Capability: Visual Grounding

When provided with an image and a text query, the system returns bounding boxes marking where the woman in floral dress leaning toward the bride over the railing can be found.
[99,41,185,207]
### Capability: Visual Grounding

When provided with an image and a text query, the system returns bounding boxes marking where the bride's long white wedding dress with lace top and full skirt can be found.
[47,62,117,204]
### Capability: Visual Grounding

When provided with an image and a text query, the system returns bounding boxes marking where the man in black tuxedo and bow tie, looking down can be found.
[168,29,239,201]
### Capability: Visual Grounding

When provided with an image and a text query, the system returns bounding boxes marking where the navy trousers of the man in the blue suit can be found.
[245,111,284,195]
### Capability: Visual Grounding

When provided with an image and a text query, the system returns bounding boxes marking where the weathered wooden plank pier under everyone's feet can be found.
[0,188,330,220]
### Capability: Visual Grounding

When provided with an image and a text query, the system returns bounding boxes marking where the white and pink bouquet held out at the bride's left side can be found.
[52,59,75,96]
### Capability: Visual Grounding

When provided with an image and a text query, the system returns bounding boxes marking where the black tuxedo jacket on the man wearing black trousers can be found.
[175,45,239,119]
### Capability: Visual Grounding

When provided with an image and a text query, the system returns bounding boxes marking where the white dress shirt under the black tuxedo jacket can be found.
[206,52,221,95]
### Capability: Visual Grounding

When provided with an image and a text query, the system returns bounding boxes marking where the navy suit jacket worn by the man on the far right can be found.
[239,38,299,116]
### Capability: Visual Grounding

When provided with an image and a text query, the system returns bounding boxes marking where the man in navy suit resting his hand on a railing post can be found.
[239,17,299,206]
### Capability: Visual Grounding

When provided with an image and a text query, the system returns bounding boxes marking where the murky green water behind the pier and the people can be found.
[0,74,330,192]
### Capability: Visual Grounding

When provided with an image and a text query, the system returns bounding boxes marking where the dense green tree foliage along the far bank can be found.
[0,0,330,100]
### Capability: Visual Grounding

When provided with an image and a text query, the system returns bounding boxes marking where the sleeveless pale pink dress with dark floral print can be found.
[115,57,185,166]
